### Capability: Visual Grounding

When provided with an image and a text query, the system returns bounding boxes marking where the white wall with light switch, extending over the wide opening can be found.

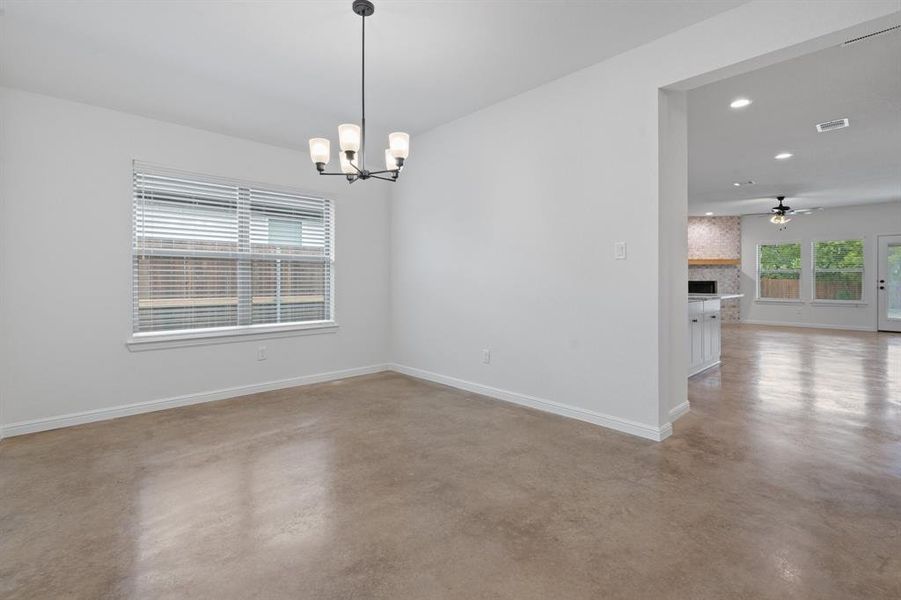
[391,2,899,437]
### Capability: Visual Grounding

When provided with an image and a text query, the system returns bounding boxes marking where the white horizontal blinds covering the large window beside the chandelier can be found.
[132,162,333,334]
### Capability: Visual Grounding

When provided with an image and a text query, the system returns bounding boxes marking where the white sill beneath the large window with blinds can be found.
[125,321,338,352]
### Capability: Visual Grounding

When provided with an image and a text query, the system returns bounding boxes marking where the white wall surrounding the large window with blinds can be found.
[0,88,390,427]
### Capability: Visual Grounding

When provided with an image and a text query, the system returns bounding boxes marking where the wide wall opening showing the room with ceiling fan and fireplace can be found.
[659,15,901,422]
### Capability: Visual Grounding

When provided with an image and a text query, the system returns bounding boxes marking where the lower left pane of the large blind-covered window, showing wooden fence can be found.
[134,256,238,331]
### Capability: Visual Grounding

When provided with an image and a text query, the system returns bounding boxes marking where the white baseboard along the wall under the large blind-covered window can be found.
[0,364,389,439]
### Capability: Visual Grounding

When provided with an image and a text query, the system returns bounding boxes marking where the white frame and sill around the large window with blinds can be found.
[125,160,339,351]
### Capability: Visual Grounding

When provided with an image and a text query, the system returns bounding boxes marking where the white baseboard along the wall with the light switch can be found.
[389,364,673,442]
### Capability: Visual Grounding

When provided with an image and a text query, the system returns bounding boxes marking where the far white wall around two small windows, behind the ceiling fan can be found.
[741,202,901,331]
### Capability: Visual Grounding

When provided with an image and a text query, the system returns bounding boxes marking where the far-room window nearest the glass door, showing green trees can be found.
[812,240,863,302]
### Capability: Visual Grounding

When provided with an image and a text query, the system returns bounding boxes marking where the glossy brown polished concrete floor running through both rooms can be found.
[0,326,901,600]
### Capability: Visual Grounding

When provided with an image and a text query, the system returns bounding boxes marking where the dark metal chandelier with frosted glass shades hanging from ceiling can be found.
[310,0,410,183]
